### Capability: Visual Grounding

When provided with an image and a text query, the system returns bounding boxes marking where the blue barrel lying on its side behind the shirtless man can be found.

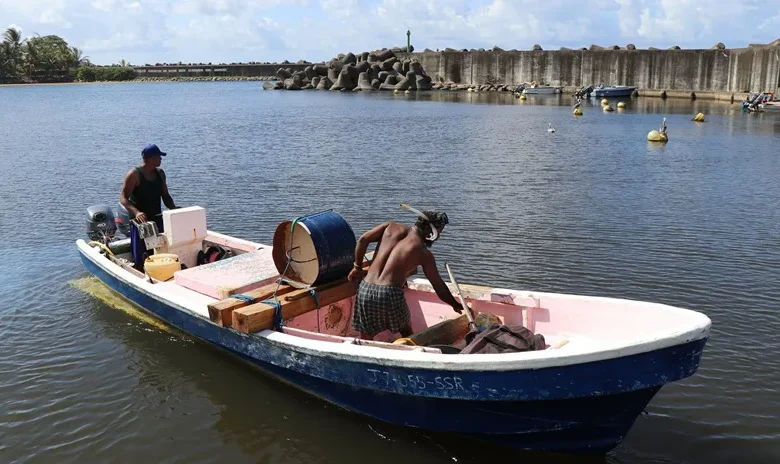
[273,211,357,286]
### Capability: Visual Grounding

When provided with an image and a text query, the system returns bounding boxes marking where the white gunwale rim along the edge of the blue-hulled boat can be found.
[76,239,711,372]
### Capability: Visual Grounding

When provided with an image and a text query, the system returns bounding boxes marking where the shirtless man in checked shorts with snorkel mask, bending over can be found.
[349,211,463,340]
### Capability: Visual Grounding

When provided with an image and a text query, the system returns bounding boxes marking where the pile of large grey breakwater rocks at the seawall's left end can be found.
[268,49,433,92]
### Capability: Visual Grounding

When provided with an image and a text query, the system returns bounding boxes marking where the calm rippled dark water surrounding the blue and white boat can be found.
[0,83,780,463]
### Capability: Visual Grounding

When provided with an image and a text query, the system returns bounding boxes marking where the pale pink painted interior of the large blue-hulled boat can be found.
[94,207,700,353]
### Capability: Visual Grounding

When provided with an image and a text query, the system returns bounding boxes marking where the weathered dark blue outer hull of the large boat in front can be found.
[81,248,706,454]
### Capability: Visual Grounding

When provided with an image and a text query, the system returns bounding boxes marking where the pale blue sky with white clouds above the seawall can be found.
[0,0,780,64]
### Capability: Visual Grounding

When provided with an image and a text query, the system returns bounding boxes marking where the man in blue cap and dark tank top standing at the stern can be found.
[119,143,176,269]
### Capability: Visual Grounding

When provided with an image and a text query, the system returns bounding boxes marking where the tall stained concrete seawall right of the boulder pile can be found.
[397,46,780,95]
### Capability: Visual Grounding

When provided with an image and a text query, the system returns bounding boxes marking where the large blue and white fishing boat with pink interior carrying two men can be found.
[76,206,711,454]
